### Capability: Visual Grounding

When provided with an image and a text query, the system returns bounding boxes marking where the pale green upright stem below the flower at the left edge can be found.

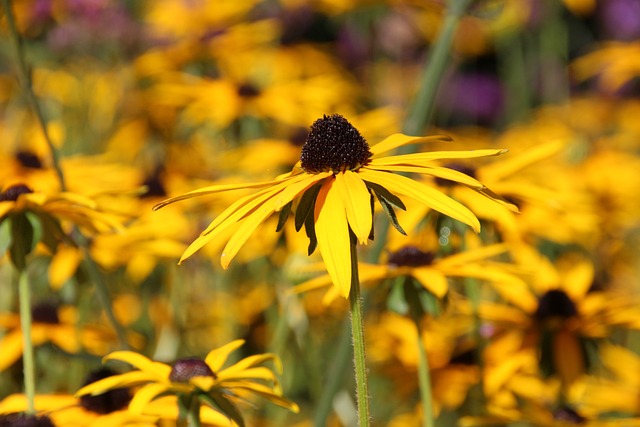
[18,271,36,414]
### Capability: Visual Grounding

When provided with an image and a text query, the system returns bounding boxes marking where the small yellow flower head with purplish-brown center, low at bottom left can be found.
[76,340,298,425]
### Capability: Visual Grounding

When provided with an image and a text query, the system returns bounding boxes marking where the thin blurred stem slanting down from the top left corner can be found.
[2,0,66,191]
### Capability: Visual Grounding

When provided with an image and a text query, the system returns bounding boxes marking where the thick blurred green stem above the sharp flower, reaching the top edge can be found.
[403,0,472,135]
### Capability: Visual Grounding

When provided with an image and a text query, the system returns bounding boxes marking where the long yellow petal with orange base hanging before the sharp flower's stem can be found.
[314,179,355,298]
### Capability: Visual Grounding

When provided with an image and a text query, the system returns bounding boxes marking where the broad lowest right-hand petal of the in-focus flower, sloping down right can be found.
[359,168,480,232]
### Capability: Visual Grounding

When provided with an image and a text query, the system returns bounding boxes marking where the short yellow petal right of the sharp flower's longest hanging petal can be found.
[334,171,373,245]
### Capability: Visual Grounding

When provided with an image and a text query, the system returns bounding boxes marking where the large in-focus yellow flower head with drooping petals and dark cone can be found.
[155,114,504,298]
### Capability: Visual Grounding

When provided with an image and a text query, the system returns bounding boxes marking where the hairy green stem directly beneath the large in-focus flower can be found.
[349,244,371,427]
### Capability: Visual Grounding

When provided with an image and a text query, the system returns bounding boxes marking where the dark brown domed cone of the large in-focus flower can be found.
[300,114,372,173]
